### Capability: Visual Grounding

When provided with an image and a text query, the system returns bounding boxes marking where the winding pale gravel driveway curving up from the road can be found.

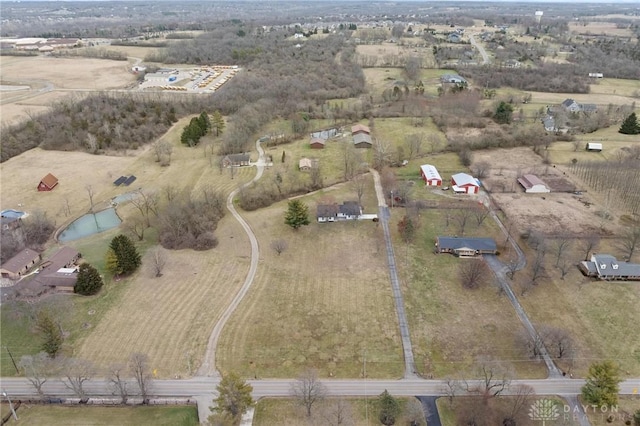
[198,140,266,376]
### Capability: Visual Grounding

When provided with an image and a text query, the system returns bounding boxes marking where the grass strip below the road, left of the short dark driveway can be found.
[253,395,424,426]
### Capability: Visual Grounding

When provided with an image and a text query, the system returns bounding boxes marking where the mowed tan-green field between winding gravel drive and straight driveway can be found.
[216,177,404,378]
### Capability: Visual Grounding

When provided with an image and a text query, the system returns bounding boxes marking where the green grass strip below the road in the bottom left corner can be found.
[0,404,199,426]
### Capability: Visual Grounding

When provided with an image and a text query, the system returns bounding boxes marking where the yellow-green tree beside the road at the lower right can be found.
[582,360,622,407]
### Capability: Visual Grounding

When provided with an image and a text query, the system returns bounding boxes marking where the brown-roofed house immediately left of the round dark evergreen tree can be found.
[35,246,82,291]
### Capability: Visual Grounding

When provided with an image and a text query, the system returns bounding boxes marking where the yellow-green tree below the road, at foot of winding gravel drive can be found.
[210,373,253,425]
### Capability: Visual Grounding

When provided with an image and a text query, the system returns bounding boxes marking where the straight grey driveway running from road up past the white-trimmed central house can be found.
[370,169,417,379]
